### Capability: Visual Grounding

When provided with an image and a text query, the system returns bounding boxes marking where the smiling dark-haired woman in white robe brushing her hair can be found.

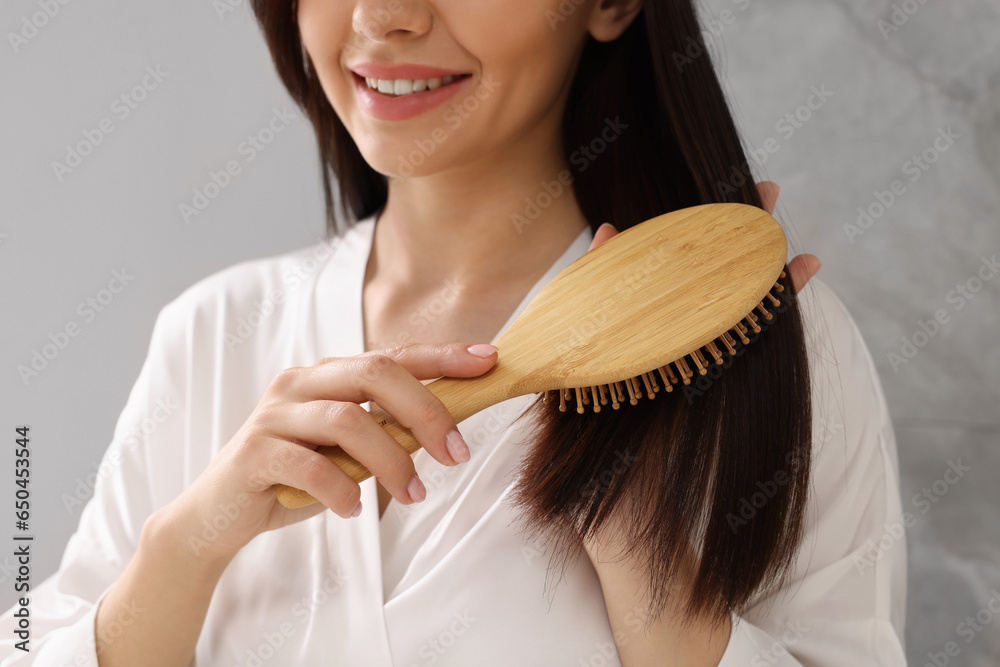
[4,0,905,667]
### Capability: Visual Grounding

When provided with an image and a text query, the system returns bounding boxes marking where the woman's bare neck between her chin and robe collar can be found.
[369,118,588,295]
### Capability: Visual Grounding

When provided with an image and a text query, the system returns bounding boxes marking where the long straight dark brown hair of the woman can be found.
[251,0,812,619]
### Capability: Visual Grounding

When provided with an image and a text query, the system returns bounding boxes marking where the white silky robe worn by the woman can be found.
[0,218,906,667]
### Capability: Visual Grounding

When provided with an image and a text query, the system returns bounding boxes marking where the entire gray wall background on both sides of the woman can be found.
[0,0,1000,667]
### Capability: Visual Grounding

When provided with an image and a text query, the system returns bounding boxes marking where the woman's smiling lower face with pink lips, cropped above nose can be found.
[298,0,596,178]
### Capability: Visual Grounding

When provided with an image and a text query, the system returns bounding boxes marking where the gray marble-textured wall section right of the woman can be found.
[701,0,1000,667]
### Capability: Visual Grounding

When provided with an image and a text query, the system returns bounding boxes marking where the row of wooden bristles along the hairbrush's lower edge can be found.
[542,271,785,414]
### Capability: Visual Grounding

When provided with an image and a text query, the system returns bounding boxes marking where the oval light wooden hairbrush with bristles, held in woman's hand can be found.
[275,204,786,508]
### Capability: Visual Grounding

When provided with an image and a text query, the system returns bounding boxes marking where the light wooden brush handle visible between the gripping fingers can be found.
[274,360,528,509]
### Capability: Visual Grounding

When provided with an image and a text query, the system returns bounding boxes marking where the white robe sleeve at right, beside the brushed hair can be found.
[719,279,913,667]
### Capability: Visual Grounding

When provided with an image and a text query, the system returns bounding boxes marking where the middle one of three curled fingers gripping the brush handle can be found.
[270,401,426,505]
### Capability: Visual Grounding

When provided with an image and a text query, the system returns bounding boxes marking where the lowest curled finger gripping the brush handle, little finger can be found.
[257,438,361,519]
